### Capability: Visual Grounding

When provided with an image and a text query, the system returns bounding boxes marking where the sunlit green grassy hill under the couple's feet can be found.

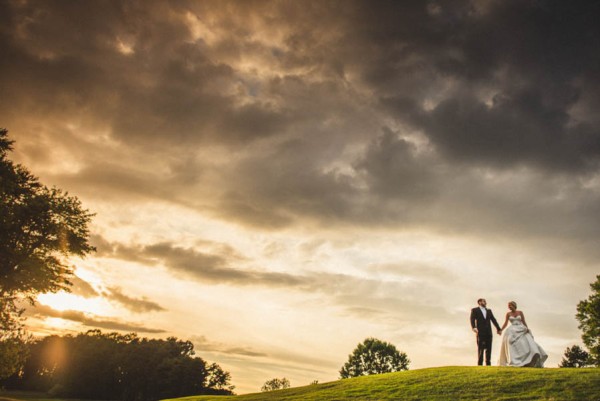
[166,367,600,401]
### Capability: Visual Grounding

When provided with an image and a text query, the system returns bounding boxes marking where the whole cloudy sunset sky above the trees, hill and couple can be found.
[0,0,600,394]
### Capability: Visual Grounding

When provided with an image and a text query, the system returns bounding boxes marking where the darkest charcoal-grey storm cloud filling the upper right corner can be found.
[359,1,600,172]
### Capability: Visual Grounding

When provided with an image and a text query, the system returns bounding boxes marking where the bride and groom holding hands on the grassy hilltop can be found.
[471,298,548,368]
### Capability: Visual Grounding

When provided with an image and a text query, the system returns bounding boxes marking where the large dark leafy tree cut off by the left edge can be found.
[0,129,95,335]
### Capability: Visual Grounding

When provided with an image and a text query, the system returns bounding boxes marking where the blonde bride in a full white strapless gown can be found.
[498,301,548,368]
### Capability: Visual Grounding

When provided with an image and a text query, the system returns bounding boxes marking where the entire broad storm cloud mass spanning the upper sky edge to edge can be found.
[0,0,600,241]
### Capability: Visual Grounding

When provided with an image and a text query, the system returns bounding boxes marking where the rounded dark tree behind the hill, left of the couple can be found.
[340,338,410,379]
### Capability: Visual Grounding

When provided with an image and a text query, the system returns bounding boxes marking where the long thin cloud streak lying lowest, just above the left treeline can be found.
[27,304,165,334]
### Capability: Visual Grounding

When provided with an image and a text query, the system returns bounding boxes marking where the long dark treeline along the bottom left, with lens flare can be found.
[0,330,233,401]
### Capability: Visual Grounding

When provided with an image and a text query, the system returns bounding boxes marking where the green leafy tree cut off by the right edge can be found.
[576,275,600,367]
